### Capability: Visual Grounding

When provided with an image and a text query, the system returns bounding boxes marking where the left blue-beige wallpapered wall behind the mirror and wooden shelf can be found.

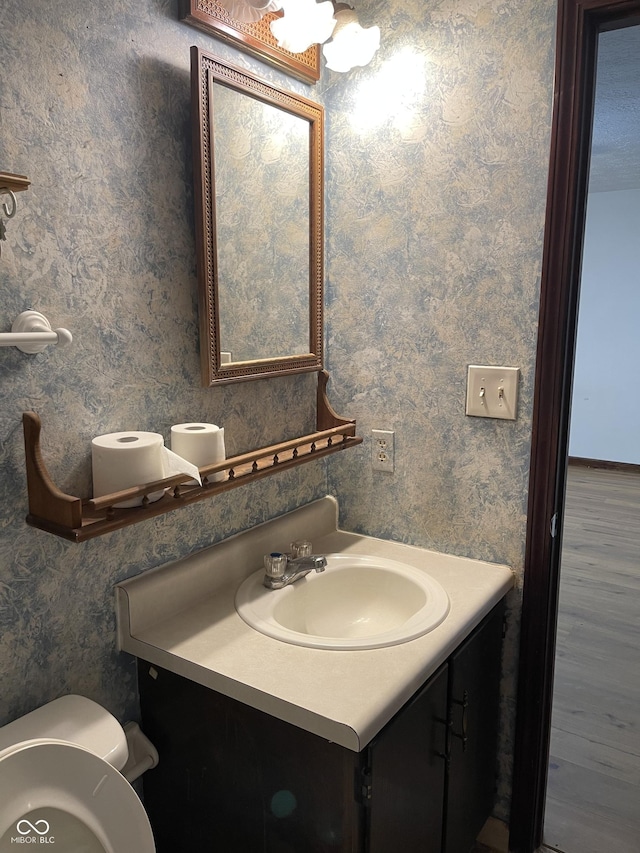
[0,0,326,724]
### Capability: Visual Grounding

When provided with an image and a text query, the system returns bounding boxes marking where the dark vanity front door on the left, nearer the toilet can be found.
[367,665,447,853]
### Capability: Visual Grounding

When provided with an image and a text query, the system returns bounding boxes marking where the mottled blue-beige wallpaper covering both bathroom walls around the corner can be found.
[0,0,555,817]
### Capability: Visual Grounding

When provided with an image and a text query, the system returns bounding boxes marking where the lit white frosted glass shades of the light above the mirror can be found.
[220,0,380,71]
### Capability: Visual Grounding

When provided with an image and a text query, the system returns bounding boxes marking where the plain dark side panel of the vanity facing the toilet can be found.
[139,662,362,853]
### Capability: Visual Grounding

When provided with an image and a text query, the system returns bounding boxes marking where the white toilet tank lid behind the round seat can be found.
[0,694,129,770]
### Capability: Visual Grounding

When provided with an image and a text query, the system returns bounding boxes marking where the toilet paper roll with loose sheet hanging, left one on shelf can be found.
[91,432,200,507]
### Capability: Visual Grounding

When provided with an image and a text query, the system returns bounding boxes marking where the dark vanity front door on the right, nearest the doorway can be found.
[443,604,504,853]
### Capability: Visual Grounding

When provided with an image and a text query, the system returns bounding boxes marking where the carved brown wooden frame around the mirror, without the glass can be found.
[191,46,324,386]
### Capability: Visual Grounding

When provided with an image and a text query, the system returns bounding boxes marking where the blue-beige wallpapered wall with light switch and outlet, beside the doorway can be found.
[323,0,556,818]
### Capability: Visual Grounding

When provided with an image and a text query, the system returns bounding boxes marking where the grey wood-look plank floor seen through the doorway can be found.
[544,466,640,853]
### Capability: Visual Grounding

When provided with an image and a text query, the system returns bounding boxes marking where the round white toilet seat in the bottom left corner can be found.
[0,738,155,853]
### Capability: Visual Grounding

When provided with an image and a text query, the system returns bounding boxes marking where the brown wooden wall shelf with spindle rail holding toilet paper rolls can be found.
[22,371,362,542]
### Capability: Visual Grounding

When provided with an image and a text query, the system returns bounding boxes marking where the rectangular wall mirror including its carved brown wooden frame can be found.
[191,47,324,385]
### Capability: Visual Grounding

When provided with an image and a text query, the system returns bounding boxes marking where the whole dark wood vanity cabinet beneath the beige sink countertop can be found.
[139,605,502,853]
